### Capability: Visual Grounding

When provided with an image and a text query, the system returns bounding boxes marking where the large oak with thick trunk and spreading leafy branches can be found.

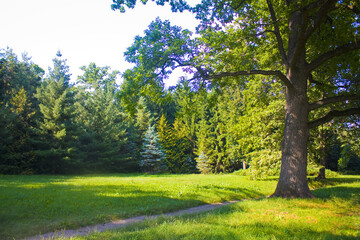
[112,0,360,197]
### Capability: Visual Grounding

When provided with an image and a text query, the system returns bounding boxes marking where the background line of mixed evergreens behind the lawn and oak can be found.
[0,46,360,178]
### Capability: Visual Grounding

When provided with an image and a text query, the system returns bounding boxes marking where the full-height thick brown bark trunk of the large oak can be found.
[272,8,313,198]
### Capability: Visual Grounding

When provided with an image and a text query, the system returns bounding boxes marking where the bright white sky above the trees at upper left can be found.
[0,0,199,86]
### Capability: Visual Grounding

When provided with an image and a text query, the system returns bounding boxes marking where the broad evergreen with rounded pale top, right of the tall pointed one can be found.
[76,63,136,172]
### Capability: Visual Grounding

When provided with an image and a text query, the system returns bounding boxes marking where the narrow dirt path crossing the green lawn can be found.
[24,201,239,240]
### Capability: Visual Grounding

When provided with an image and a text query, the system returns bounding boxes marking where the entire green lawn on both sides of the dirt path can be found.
[0,175,360,239]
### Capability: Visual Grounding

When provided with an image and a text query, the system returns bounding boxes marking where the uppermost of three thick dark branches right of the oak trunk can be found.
[308,39,360,72]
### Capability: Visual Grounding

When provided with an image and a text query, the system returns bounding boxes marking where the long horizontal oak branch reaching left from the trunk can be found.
[205,70,293,88]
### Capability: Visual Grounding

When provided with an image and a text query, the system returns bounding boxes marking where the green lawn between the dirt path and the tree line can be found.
[0,175,276,239]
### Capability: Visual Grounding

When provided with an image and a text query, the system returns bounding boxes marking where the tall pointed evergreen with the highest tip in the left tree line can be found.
[36,52,74,174]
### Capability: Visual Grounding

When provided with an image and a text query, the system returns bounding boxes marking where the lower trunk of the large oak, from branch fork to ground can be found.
[272,73,313,198]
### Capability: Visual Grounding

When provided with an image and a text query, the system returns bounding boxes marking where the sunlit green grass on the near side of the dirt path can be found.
[73,178,360,240]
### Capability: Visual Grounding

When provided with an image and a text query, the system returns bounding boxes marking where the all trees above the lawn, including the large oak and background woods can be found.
[0,0,360,196]
